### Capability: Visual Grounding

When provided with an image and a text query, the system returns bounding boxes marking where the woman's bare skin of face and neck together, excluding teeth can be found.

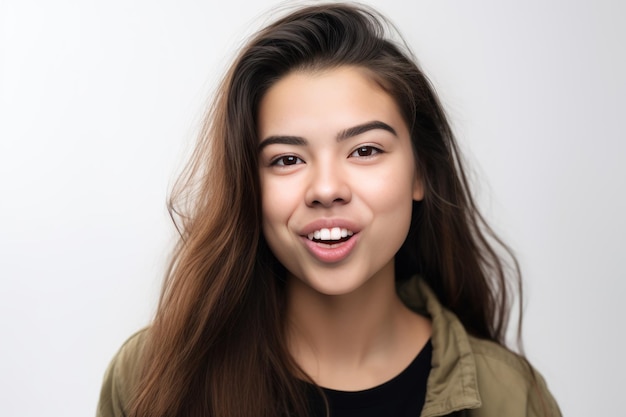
[258,67,430,390]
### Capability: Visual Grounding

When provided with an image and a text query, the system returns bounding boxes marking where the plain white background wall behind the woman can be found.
[0,0,626,417]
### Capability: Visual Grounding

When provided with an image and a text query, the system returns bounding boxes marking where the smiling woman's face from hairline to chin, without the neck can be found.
[258,67,423,295]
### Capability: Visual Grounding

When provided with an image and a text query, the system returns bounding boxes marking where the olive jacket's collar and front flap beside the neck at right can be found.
[398,276,481,417]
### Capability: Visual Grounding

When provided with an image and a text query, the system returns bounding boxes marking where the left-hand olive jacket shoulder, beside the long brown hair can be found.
[96,329,148,417]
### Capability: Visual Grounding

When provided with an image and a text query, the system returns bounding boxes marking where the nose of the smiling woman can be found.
[305,164,352,207]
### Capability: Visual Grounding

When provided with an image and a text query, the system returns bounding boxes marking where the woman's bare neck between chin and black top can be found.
[287,262,430,389]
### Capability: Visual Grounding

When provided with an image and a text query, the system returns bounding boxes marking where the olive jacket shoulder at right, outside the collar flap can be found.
[468,330,561,417]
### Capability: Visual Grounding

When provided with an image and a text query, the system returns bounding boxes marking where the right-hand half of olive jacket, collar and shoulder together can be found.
[399,277,561,417]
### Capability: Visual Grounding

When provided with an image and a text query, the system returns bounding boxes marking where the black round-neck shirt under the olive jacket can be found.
[309,340,432,417]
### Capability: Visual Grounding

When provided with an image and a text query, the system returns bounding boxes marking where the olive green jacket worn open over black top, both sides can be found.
[97,278,561,417]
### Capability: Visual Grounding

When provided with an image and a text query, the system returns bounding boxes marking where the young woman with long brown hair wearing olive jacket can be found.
[98,4,560,417]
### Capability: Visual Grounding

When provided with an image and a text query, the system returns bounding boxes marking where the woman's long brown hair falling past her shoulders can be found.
[131,4,519,417]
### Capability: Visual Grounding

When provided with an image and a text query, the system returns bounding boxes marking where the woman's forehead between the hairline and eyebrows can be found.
[257,66,406,139]
